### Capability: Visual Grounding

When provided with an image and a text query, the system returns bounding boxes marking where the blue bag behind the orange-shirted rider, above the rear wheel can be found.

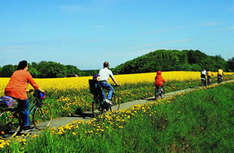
[0,96,18,108]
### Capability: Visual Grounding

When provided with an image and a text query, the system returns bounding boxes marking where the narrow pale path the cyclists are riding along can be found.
[22,80,234,134]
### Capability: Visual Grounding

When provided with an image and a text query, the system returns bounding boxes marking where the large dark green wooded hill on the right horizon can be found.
[114,50,234,74]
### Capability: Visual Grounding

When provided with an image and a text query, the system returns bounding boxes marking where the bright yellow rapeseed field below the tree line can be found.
[0,71,233,95]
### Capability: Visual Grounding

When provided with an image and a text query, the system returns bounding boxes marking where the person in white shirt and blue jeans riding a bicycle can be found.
[98,61,119,105]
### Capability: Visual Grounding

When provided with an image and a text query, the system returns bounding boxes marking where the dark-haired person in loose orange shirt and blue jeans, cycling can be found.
[5,60,42,130]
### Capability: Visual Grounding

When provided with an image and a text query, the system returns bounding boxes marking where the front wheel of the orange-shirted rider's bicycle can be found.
[33,104,53,130]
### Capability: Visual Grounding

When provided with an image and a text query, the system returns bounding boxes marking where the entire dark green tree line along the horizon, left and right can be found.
[0,50,234,78]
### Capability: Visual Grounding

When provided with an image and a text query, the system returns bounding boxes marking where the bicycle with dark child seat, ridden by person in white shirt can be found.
[89,80,120,116]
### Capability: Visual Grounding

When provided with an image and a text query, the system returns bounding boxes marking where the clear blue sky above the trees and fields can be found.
[0,0,234,69]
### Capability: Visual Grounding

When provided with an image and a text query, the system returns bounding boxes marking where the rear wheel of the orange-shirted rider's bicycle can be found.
[0,111,21,138]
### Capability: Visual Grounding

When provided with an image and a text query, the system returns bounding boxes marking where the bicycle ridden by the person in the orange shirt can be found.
[0,90,53,138]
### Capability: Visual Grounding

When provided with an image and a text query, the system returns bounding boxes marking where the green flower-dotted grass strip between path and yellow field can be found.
[46,80,200,117]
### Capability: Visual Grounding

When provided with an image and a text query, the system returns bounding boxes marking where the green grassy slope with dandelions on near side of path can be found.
[3,84,234,153]
